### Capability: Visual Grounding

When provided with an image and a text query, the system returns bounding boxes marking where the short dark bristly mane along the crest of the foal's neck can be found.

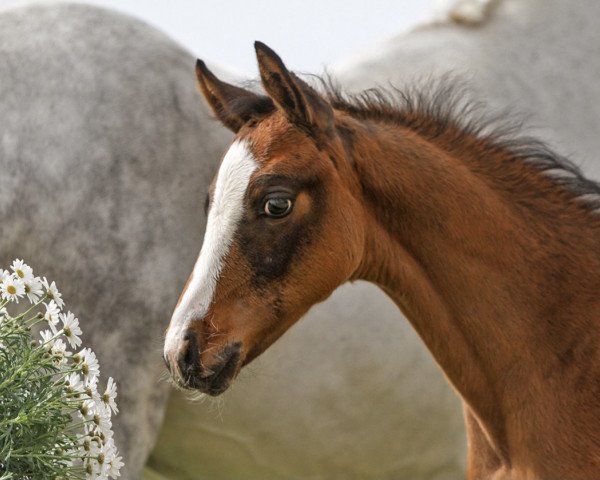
[316,75,600,216]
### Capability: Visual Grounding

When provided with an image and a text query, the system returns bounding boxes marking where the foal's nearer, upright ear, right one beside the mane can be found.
[254,42,333,133]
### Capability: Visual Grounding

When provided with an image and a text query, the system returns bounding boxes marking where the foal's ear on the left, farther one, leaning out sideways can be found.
[196,60,275,133]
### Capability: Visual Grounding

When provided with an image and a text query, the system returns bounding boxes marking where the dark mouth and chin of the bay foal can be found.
[176,342,241,396]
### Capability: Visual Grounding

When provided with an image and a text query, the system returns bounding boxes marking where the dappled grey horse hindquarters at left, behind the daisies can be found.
[0,5,229,479]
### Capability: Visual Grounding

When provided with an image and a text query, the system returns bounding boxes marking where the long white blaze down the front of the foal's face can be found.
[165,141,258,353]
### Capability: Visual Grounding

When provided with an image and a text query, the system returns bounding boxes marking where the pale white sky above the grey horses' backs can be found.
[0,0,440,77]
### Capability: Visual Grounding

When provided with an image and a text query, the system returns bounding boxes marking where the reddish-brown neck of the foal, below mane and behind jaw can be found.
[353,117,600,472]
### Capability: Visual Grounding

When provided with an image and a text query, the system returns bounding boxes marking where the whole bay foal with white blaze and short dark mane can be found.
[164,42,600,480]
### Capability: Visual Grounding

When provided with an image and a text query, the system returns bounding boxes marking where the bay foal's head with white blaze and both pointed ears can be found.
[164,42,364,395]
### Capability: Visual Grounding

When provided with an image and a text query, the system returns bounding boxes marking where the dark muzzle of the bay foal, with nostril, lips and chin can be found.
[164,330,241,396]
